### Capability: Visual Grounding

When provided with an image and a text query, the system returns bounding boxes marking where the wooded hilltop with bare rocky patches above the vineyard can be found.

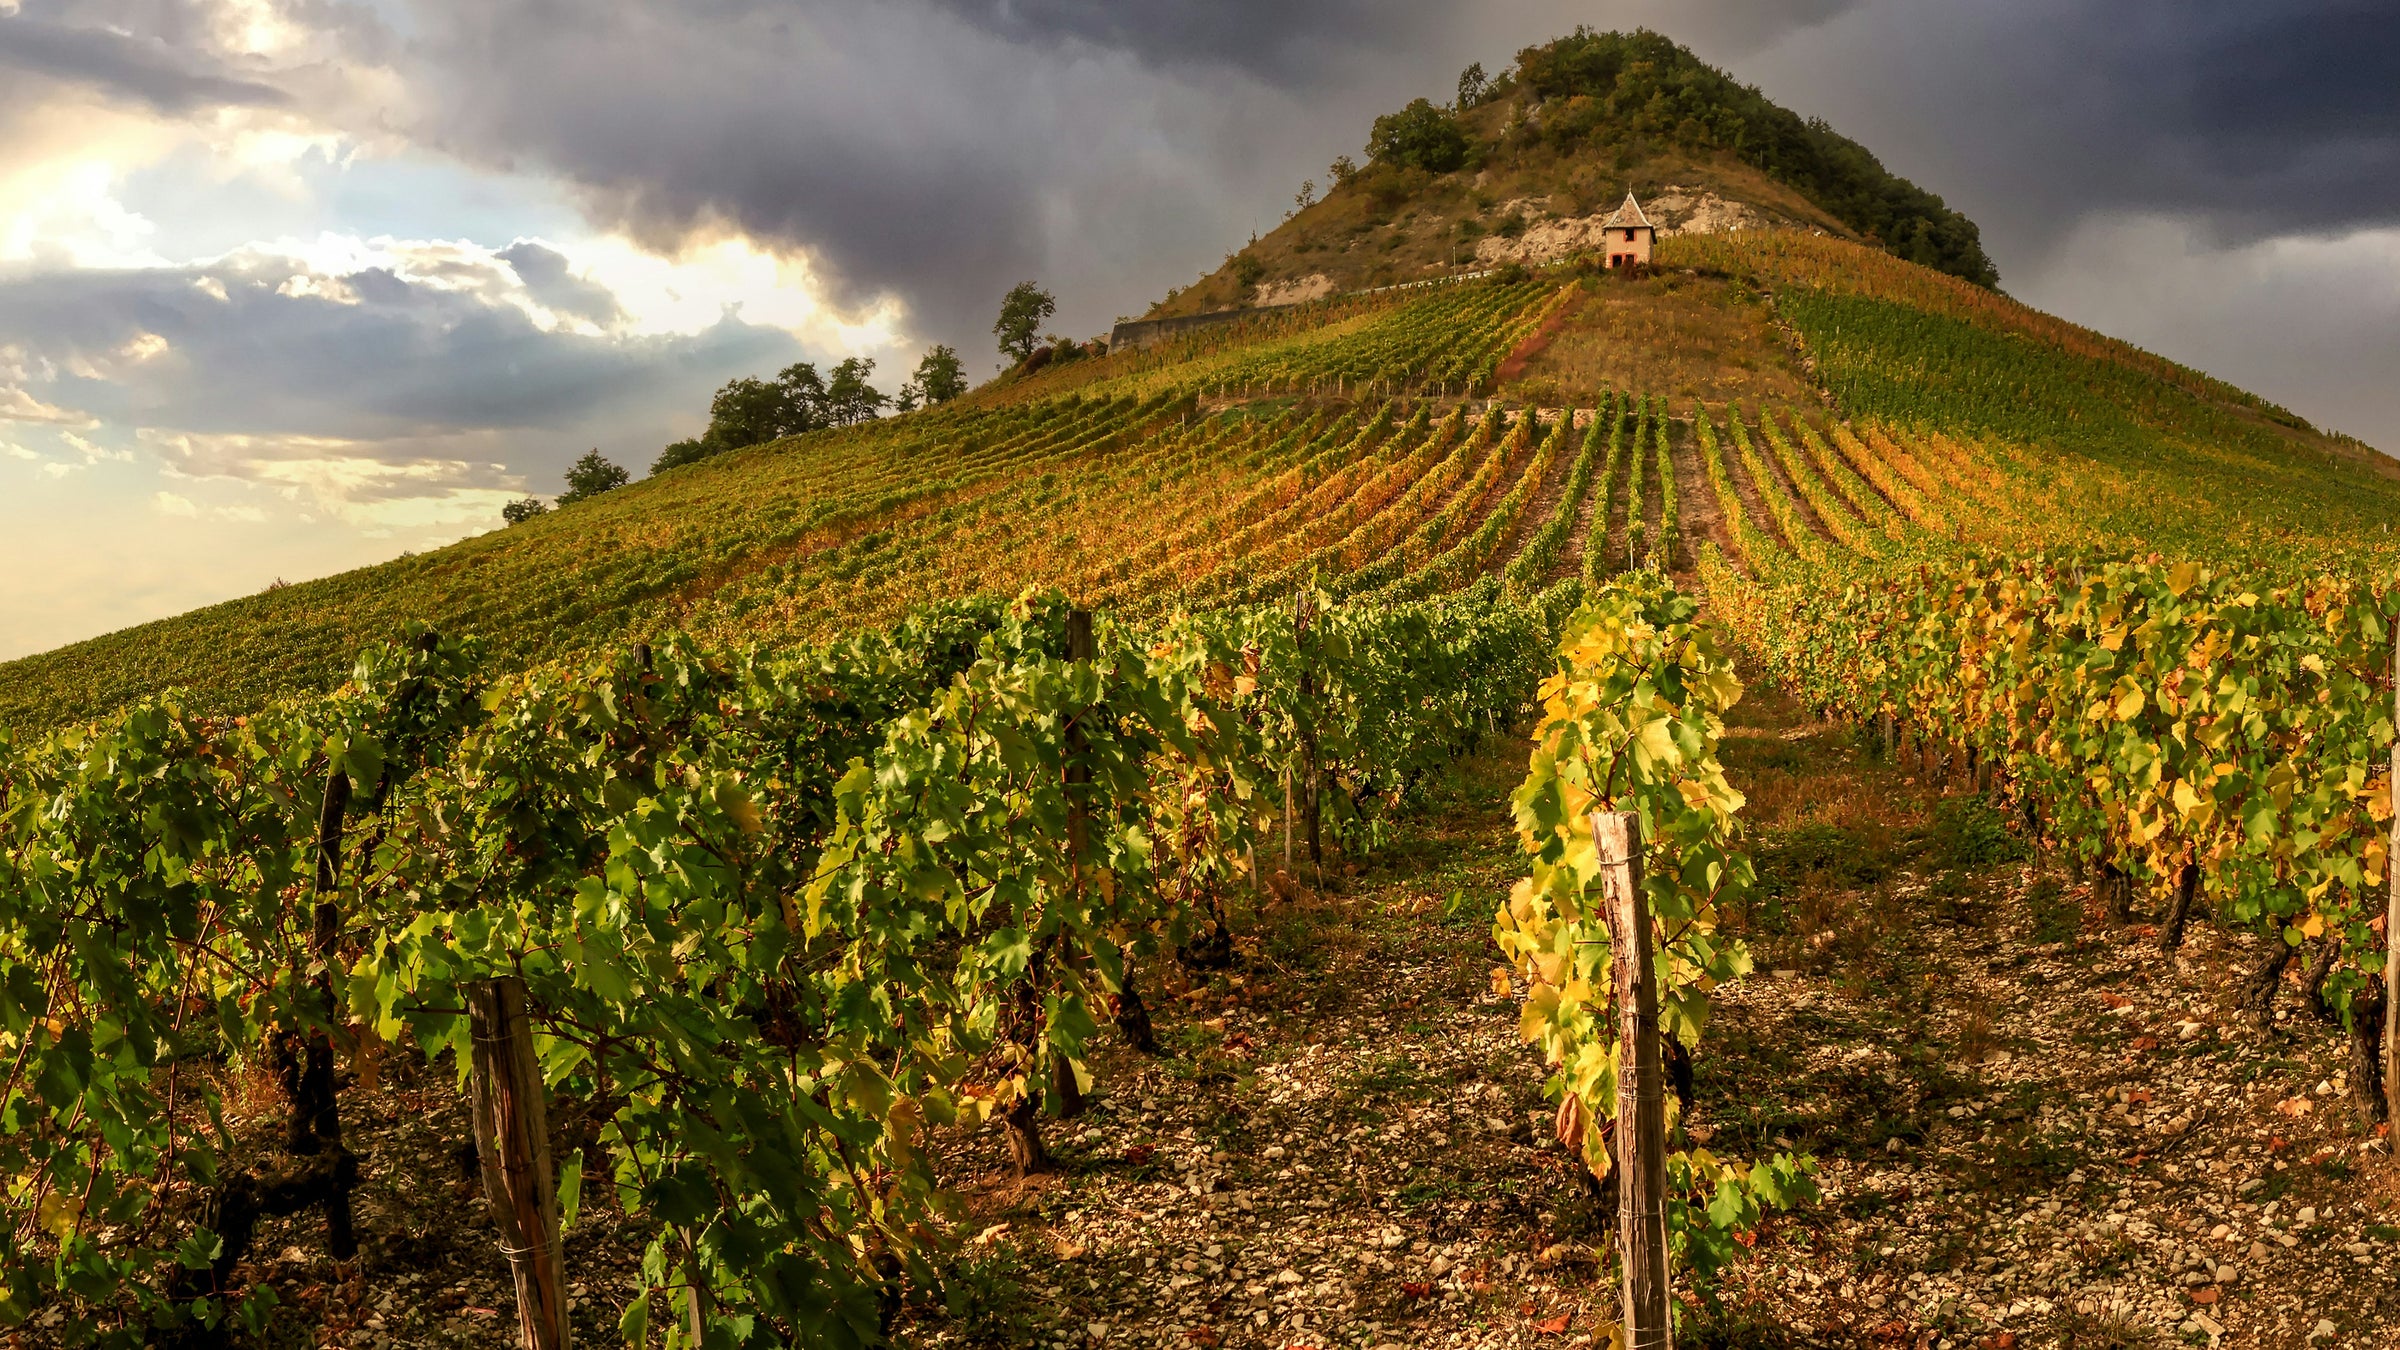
[1147,29,1999,317]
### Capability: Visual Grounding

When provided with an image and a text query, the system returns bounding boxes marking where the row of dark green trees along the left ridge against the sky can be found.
[499,281,1080,526]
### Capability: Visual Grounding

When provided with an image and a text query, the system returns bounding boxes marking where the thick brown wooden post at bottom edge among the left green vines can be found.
[466,975,566,1350]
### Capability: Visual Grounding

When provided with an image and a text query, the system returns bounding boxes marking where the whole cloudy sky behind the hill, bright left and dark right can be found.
[0,0,2400,658]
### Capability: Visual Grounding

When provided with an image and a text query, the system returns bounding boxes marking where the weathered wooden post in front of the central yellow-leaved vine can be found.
[1591,812,1673,1350]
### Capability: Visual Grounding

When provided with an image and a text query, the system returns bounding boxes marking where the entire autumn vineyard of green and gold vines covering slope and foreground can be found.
[0,220,2400,1345]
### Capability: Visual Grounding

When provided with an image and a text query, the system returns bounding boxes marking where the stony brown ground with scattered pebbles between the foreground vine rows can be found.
[32,672,2400,1350]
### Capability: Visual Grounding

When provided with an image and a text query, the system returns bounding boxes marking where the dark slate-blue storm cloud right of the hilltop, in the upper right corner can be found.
[1750,0,2400,252]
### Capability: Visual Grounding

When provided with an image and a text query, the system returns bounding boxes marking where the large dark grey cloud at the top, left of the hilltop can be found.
[360,0,1358,346]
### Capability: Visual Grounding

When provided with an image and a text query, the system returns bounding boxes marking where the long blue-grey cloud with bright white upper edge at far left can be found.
[0,259,797,442]
